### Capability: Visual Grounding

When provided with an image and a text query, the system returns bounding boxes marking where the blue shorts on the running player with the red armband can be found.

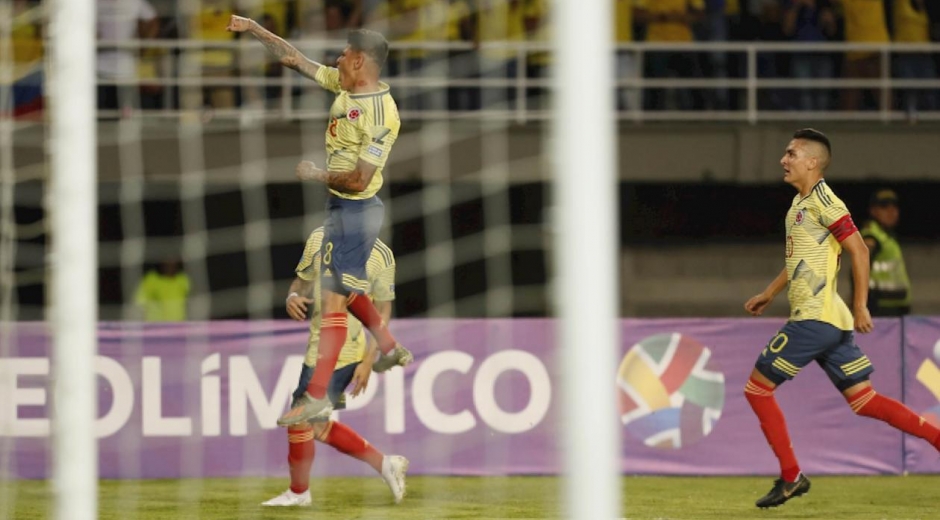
[754,320,875,390]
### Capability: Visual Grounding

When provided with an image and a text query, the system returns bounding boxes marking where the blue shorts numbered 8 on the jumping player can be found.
[320,197,385,294]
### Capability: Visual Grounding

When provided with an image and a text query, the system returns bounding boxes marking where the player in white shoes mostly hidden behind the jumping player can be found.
[261,227,408,506]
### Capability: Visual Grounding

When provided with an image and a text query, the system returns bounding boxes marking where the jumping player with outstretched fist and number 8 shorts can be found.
[228,16,414,426]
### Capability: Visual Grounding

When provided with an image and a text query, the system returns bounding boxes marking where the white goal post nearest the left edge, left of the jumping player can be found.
[46,0,98,520]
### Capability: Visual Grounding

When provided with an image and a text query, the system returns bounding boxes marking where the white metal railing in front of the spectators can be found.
[82,38,940,123]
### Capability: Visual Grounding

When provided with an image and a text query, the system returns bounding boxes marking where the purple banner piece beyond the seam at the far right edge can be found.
[904,316,940,473]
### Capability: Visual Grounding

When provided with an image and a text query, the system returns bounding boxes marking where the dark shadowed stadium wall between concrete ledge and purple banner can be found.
[16,180,940,320]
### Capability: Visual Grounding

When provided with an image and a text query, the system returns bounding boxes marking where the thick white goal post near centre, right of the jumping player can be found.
[550,0,620,519]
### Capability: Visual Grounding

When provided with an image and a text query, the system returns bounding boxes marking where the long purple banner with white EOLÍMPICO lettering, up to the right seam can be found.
[0,319,912,478]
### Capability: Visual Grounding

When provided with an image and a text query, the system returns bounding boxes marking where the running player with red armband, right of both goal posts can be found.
[744,129,940,508]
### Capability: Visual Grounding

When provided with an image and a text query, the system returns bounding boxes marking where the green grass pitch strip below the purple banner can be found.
[0,475,940,520]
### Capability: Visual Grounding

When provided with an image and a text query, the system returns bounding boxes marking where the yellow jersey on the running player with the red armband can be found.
[786,180,858,330]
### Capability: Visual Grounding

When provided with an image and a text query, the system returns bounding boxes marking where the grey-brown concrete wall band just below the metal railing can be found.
[14,120,940,183]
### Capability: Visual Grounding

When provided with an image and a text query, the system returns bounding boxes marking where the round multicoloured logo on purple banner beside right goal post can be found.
[617,332,725,449]
